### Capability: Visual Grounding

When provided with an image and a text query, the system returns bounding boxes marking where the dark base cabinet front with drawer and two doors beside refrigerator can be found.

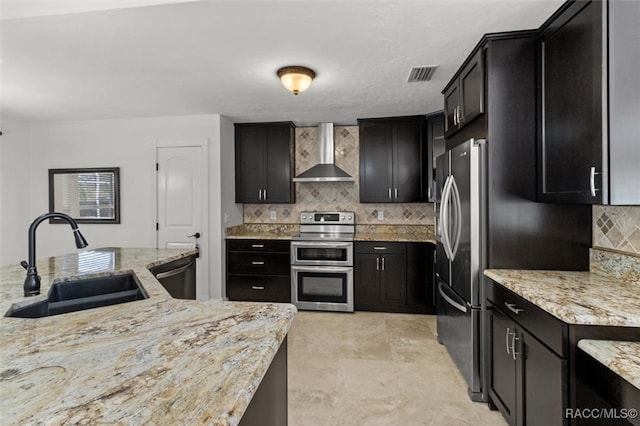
[487,280,568,425]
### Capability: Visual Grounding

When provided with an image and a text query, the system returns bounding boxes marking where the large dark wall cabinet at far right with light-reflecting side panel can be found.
[537,0,640,204]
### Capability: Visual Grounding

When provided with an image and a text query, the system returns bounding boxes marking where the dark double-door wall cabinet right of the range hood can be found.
[358,116,428,203]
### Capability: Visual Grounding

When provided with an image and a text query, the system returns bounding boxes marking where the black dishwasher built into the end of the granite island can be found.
[149,255,196,300]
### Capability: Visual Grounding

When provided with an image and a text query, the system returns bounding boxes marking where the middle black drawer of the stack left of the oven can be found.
[227,252,291,275]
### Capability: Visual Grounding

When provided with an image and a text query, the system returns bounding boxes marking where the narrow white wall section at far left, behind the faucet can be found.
[0,116,31,265]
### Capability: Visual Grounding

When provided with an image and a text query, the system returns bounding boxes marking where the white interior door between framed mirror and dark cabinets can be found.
[157,146,206,300]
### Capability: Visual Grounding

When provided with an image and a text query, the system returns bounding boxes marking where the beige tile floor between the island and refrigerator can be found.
[288,312,506,426]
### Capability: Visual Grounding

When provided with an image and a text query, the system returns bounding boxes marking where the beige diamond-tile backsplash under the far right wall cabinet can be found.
[593,206,640,256]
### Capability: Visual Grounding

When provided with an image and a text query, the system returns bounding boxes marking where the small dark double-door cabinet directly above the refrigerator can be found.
[442,51,484,137]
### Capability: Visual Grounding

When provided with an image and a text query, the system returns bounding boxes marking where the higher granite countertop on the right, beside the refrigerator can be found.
[484,269,640,327]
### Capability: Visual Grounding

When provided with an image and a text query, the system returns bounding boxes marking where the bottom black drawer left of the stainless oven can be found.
[227,275,291,303]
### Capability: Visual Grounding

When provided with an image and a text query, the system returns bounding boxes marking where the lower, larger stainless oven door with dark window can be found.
[291,266,353,312]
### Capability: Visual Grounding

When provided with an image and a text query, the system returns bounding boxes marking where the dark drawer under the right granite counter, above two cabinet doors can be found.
[487,280,568,358]
